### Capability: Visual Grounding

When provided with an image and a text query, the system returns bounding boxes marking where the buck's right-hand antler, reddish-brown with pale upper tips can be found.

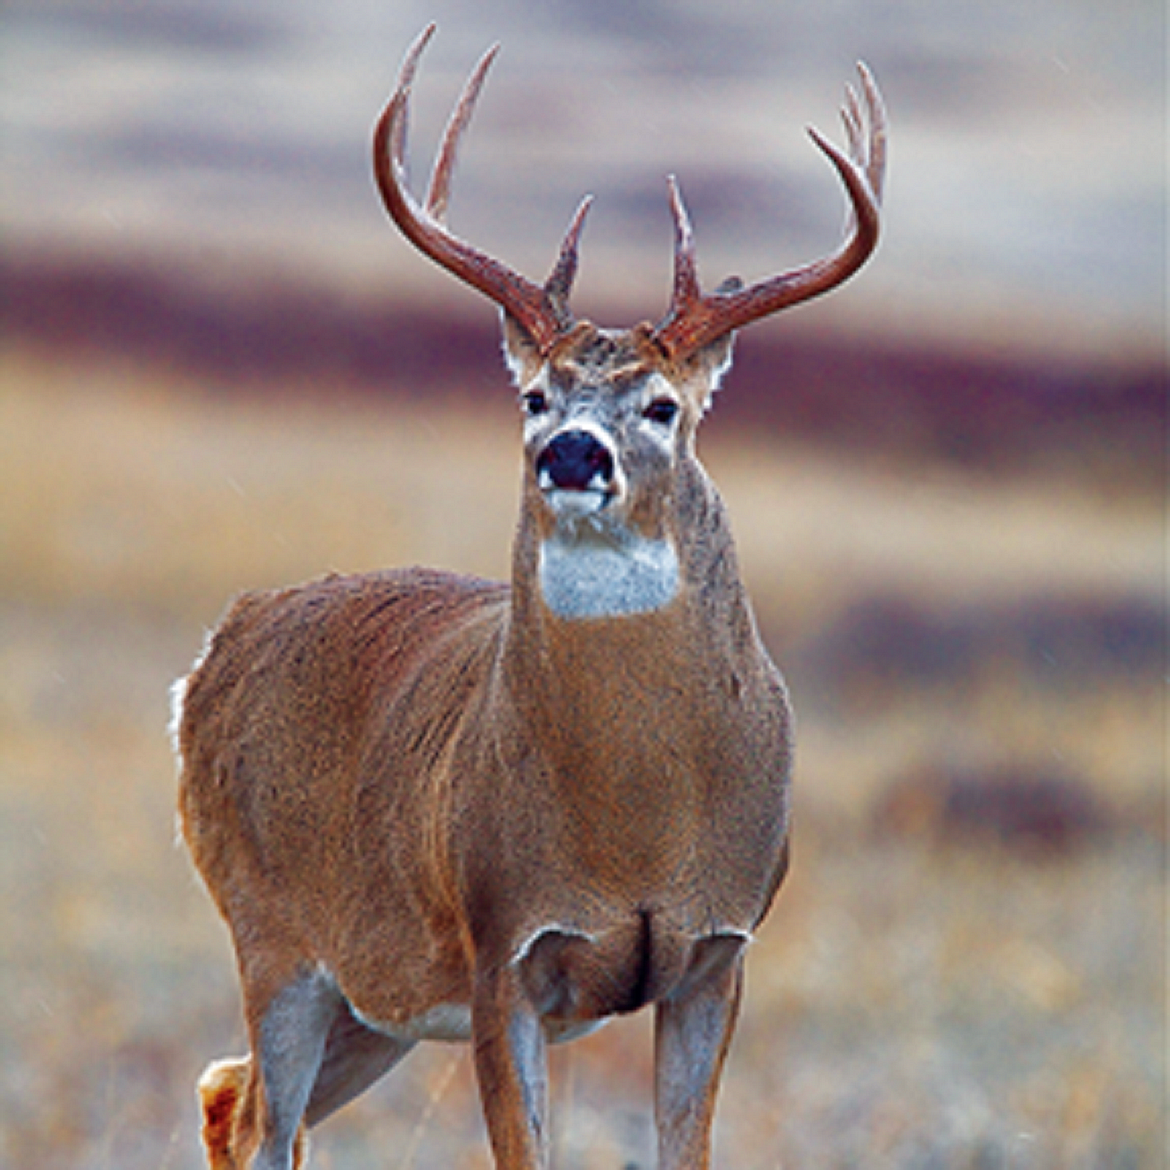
[653,63,886,360]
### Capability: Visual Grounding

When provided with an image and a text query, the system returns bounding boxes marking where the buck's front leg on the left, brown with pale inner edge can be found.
[472,965,549,1170]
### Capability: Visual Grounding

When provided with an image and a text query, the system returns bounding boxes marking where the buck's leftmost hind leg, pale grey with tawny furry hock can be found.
[199,973,342,1170]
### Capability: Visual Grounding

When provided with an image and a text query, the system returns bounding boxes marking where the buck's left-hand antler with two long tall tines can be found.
[373,23,592,353]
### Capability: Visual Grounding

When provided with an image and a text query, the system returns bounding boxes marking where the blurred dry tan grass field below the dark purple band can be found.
[0,341,1166,1170]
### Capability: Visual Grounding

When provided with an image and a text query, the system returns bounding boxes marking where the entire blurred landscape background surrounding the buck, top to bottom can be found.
[0,0,1168,1170]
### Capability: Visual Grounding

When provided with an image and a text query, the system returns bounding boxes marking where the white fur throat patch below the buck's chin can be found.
[539,522,679,619]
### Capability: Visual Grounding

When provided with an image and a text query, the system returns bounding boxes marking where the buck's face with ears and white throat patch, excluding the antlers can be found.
[504,319,729,617]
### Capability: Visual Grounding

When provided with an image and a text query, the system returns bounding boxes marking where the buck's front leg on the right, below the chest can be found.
[654,935,748,1170]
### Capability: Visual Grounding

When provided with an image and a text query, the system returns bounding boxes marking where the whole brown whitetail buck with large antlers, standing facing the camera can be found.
[177,28,885,1170]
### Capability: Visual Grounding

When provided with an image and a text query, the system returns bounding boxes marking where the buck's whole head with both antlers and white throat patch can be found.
[374,25,886,615]
